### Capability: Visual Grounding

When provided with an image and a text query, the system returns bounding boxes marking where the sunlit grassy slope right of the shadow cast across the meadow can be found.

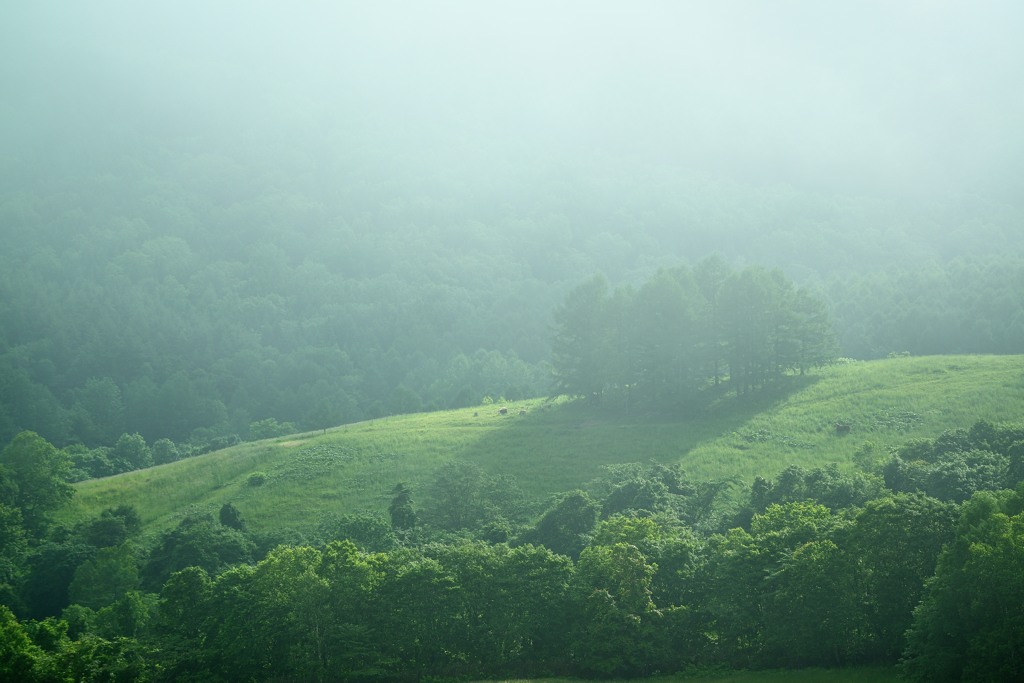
[671,356,1024,481]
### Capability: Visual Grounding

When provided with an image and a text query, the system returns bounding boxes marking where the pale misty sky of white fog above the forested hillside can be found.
[0,0,1024,198]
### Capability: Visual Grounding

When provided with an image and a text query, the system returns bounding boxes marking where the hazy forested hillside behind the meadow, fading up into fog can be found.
[0,96,1024,446]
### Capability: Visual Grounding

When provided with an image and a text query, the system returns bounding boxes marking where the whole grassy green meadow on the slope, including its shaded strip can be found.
[58,356,1024,531]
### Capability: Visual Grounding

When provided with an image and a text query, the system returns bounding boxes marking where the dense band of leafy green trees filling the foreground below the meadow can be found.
[6,422,1024,681]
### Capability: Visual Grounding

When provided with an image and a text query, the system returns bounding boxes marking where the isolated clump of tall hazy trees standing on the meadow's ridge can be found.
[552,257,839,403]
